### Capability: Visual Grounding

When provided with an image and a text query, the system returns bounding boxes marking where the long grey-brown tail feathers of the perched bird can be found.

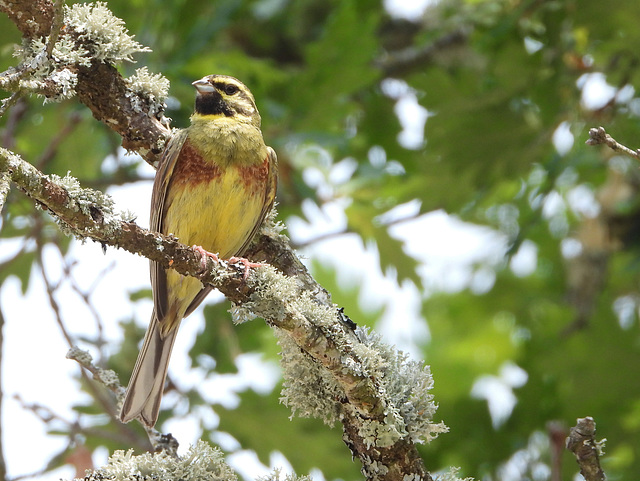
[120,313,178,428]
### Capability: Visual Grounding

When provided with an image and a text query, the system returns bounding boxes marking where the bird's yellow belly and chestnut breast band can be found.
[163,136,269,319]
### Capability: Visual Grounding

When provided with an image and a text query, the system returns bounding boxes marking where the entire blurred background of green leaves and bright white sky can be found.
[0,0,640,481]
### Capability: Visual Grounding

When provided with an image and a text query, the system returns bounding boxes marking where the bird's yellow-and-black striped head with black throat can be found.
[193,75,260,128]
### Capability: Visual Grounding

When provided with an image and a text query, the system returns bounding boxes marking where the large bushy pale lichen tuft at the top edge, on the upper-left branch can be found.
[64,2,151,63]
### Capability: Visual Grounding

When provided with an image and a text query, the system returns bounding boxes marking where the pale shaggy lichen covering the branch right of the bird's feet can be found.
[234,258,448,447]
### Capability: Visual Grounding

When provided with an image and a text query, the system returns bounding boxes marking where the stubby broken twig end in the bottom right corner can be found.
[567,416,607,481]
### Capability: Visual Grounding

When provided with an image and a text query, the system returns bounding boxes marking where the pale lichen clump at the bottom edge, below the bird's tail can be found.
[84,441,237,481]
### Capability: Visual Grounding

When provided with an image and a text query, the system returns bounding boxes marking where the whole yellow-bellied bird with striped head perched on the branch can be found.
[120,75,277,427]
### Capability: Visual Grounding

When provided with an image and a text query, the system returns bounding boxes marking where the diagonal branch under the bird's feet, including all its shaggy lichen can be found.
[0,149,446,480]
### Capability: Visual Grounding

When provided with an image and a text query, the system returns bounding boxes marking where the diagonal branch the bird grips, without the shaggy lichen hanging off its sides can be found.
[0,149,445,481]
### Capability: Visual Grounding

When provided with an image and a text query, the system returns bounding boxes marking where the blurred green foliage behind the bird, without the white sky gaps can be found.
[0,0,640,479]
